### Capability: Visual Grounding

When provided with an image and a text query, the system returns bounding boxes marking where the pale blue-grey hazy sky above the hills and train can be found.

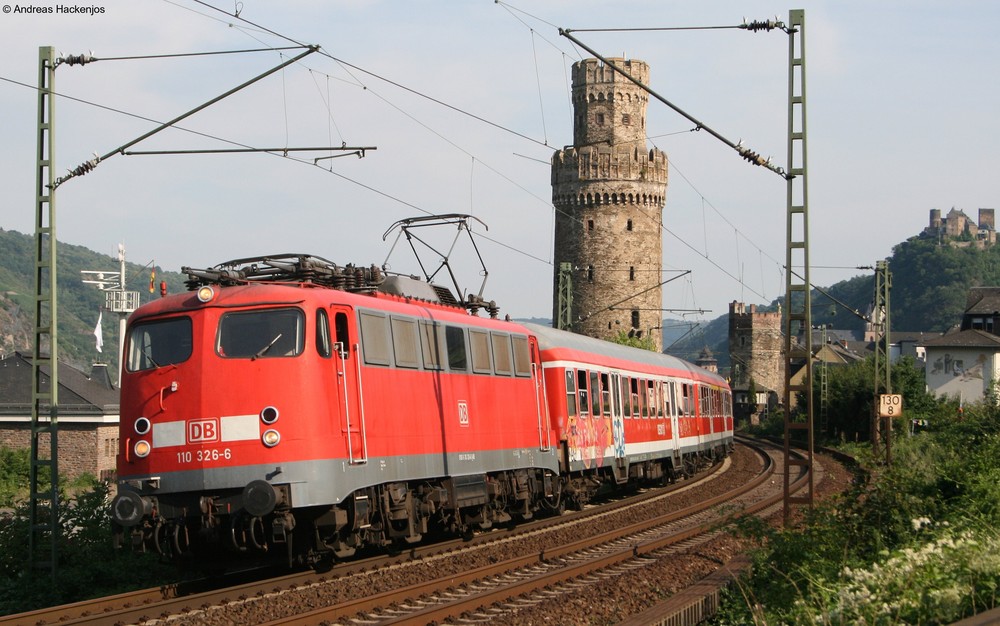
[0,0,1000,326]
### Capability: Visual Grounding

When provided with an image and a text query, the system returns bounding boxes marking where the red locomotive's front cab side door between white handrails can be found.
[330,306,368,464]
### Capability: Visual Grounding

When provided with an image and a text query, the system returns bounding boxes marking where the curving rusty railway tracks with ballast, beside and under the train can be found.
[0,438,781,625]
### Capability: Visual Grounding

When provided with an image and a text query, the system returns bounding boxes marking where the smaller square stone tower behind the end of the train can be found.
[729,302,785,398]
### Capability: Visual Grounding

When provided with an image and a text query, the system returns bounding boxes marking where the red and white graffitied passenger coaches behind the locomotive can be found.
[527,324,733,498]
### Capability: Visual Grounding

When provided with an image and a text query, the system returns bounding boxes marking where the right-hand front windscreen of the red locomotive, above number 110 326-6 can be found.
[222,309,305,359]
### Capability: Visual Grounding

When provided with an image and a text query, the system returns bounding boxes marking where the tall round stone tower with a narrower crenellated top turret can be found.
[552,58,667,351]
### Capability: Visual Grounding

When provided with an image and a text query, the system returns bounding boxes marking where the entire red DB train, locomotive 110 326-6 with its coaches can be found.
[112,255,732,562]
